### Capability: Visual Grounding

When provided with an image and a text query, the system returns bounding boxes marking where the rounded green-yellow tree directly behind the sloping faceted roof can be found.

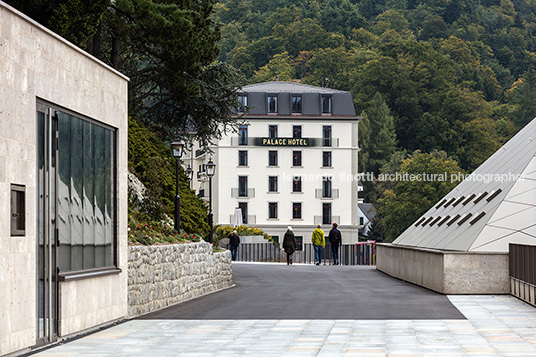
[374,151,463,242]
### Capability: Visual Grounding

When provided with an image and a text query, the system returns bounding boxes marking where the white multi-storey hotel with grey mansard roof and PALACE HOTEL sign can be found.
[185,81,359,243]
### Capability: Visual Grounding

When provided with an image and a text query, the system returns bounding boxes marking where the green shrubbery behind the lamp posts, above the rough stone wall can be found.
[128,118,208,234]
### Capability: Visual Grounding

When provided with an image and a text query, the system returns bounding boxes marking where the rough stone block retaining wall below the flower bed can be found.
[128,242,233,317]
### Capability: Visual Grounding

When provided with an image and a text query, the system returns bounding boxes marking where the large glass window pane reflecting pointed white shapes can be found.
[57,112,115,272]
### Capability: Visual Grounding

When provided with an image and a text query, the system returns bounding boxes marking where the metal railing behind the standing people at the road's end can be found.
[232,242,376,265]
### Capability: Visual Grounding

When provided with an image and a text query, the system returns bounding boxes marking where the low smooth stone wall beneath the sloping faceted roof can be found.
[376,243,510,294]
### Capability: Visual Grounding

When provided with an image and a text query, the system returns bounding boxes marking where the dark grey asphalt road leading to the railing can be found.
[140,263,465,320]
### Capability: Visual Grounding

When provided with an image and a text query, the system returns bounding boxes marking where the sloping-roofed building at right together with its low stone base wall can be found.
[377,119,536,294]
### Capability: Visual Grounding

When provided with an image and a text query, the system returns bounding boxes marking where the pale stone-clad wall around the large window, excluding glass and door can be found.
[0,2,128,355]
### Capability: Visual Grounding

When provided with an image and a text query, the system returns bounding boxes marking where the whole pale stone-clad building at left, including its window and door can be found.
[0,2,128,355]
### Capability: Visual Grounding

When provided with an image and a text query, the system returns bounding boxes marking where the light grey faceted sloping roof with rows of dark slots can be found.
[393,119,536,252]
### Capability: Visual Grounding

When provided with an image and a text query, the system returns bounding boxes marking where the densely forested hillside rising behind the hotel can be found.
[215,0,536,172]
